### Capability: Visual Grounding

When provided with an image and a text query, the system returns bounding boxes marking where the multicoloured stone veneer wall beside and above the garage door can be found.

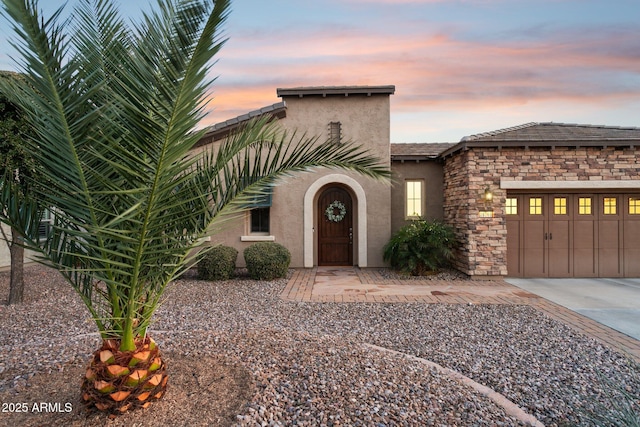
[444,147,640,277]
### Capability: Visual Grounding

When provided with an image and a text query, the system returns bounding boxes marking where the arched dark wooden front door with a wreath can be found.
[318,187,353,265]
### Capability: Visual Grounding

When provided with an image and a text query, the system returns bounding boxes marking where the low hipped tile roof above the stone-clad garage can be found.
[442,122,640,156]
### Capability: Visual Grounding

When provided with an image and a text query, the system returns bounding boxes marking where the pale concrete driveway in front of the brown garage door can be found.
[506,278,640,340]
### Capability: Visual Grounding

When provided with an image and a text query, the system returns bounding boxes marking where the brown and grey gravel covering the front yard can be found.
[0,266,640,426]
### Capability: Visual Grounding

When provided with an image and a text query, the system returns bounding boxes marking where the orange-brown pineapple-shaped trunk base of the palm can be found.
[82,337,168,414]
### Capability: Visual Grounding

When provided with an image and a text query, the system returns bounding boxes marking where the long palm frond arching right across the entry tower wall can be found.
[198,117,390,224]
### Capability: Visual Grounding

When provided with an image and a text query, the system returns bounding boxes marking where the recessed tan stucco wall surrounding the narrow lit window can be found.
[391,160,444,234]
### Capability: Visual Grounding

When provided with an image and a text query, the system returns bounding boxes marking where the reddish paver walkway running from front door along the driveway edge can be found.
[281,267,640,362]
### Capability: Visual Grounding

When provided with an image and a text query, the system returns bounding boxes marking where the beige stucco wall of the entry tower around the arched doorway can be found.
[202,95,391,267]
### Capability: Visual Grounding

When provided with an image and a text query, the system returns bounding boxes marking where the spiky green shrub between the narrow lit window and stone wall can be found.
[384,219,457,276]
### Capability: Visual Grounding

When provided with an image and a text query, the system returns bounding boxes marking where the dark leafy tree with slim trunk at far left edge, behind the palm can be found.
[0,71,39,304]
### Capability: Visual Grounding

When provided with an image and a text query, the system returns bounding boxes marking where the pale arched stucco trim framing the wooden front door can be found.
[304,173,368,268]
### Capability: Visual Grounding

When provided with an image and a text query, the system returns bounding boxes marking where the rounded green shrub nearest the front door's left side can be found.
[244,242,291,280]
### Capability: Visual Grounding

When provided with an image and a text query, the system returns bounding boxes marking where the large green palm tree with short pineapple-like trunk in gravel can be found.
[3,0,388,413]
